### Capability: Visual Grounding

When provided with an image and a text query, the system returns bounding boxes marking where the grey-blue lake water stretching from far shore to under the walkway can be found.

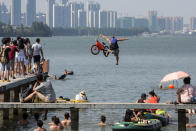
[2,36,196,131]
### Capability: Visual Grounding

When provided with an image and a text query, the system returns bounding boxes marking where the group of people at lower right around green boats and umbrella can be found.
[121,77,196,127]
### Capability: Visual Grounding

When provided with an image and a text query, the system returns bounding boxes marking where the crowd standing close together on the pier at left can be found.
[0,37,44,82]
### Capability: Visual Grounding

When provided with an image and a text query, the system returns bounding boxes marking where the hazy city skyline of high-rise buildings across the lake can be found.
[0,0,196,33]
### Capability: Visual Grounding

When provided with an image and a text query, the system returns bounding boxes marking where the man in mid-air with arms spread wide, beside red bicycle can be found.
[100,34,128,65]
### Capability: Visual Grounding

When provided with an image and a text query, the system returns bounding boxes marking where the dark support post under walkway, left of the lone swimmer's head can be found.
[70,108,79,131]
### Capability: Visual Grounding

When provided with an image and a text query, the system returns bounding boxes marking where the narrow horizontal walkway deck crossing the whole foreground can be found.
[0,102,196,110]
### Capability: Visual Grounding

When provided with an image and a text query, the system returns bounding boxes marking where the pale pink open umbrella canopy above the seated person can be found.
[161,71,190,83]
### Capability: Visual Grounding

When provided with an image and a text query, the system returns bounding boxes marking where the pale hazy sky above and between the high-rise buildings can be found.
[0,0,196,23]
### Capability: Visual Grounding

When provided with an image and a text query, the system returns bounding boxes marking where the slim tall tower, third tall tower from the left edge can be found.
[46,0,55,28]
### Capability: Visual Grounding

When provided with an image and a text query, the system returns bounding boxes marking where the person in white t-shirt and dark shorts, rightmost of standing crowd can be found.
[32,38,44,73]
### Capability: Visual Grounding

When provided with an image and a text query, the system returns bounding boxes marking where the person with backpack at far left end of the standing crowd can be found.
[0,38,11,82]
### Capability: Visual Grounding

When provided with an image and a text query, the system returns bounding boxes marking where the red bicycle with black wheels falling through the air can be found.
[90,39,109,57]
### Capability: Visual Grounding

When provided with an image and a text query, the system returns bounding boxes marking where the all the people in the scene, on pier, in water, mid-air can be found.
[0,35,196,131]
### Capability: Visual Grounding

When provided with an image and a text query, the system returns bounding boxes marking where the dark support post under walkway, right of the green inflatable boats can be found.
[178,109,186,131]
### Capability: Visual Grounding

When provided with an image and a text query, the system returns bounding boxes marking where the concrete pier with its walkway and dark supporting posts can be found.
[0,75,192,131]
